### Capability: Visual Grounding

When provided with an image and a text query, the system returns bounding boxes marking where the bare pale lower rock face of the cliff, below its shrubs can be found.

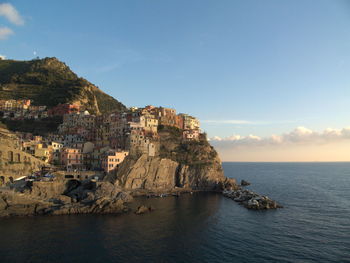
[109,154,235,192]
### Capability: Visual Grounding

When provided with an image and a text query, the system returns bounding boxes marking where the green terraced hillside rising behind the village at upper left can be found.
[0,58,125,114]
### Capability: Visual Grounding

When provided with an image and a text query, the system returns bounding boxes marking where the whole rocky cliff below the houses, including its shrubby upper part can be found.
[109,127,236,192]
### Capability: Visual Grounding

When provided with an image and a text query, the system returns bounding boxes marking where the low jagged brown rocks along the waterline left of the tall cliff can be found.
[0,182,133,217]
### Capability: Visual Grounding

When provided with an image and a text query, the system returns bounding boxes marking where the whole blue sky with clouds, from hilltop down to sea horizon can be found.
[0,0,350,161]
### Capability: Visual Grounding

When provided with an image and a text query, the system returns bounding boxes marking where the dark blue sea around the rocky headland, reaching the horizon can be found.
[0,163,350,262]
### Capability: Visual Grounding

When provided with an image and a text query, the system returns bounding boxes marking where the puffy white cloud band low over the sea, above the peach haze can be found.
[210,127,350,148]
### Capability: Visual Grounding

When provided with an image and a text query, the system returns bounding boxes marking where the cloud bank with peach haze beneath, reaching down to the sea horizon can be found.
[210,127,350,162]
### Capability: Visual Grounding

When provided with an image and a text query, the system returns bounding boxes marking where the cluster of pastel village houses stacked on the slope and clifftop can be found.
[12,104,201,172]
